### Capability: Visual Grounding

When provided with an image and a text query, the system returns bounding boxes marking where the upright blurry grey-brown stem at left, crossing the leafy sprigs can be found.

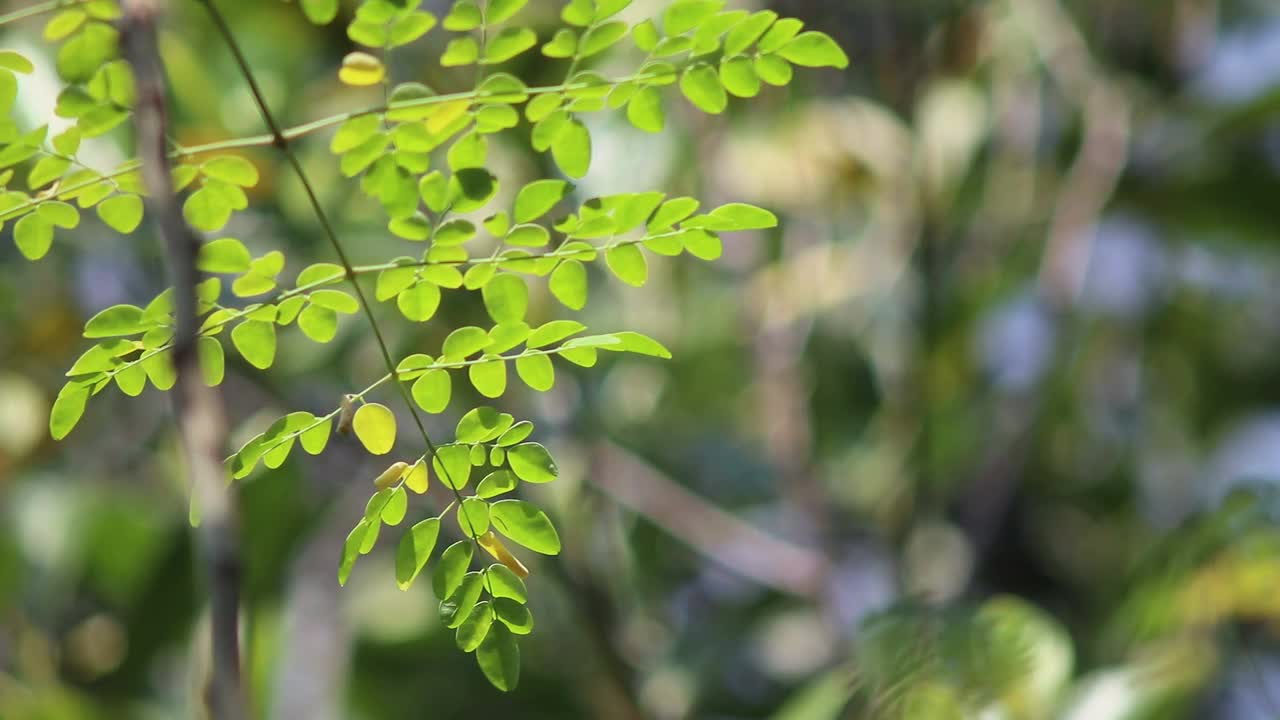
[120,0,246,720]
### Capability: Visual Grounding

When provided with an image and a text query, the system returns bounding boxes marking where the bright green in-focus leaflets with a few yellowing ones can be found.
[10,0,847,691]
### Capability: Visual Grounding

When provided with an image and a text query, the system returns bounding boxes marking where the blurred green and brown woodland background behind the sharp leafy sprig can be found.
[0,0,1280,720]
